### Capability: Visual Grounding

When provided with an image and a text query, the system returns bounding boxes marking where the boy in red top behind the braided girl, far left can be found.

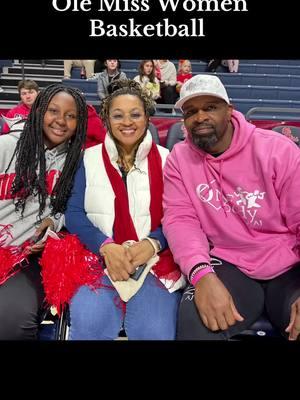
[2,79,39,133]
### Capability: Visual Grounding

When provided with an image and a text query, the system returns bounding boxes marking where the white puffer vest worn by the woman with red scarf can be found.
[84,130,169,239]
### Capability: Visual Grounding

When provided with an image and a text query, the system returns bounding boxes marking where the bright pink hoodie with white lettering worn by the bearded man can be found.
[163,111,300,279]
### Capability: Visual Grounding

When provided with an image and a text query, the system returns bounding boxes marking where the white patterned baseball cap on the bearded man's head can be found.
[174,74,230,109]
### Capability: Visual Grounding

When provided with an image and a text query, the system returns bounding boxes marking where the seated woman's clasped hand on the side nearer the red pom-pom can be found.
[101,243,135,281]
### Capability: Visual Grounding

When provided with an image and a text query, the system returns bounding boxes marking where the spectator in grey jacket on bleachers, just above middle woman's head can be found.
[97,60,126,101]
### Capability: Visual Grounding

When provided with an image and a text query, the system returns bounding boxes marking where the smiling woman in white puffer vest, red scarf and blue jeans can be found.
[65,80,185,340]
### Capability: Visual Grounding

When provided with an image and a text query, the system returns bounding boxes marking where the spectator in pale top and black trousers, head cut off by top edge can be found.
[158,60,177,106]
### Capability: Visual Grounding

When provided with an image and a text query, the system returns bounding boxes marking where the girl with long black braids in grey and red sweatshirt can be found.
[0,84,87,340]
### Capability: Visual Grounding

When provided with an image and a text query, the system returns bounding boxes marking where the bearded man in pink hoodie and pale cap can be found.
[163,74,300,340]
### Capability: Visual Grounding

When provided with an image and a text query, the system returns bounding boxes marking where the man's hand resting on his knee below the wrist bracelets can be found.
[195,273,244,331]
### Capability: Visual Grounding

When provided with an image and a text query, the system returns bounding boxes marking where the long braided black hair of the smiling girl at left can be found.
[12,83,87,218]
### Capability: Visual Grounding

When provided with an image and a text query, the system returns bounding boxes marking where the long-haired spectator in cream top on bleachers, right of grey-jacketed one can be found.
[134,60,160,100]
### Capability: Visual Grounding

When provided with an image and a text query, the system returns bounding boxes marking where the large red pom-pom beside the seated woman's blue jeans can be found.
[40,234,103,314]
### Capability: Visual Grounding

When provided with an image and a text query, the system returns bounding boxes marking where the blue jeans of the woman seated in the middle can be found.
[69,273,182,340]
